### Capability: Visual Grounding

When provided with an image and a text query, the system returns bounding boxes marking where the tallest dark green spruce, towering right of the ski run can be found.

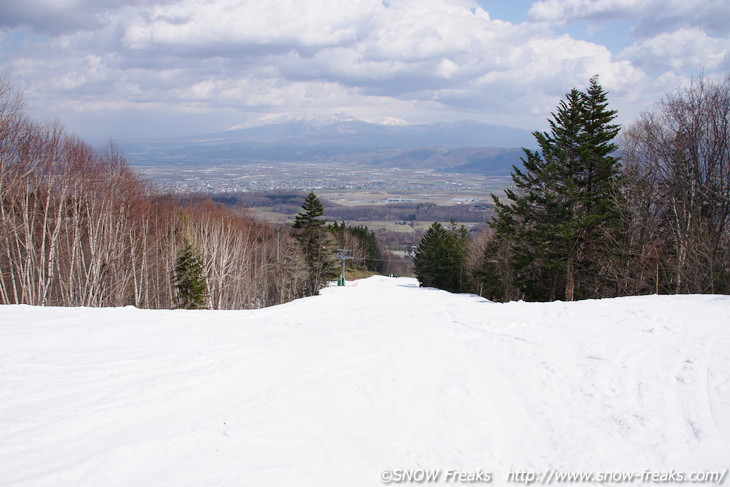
[483,77,620,301]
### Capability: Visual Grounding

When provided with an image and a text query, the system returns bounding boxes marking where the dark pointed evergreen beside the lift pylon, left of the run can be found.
[294,192,337,295]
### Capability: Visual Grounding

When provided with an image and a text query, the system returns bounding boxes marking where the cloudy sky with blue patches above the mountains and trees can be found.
[0,0,730,139]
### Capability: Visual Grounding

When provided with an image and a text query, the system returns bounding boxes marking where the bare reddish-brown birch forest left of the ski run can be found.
[0,82,386,309]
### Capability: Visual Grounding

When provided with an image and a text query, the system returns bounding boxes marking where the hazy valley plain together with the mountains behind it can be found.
[121,114,516,251]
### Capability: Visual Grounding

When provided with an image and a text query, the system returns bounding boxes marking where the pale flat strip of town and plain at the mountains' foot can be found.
[133,162,510,204]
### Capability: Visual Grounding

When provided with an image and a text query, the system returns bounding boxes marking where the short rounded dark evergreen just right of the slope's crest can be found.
[413,220,468,292]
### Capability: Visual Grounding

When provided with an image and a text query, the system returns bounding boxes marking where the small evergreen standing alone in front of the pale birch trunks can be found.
[174,240,208,309]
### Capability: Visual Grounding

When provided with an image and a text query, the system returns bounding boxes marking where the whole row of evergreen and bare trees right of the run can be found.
[414,77,730,301]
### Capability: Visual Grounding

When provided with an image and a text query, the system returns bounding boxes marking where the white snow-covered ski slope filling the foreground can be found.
[0,277,730,487]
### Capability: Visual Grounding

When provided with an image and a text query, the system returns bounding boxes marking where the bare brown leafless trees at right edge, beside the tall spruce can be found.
[622,78,730,293]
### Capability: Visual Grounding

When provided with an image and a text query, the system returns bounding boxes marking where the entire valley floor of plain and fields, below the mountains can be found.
[135,162,511,250]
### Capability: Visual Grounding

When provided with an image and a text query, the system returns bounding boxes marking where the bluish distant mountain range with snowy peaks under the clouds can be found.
[121,114,534,175]
